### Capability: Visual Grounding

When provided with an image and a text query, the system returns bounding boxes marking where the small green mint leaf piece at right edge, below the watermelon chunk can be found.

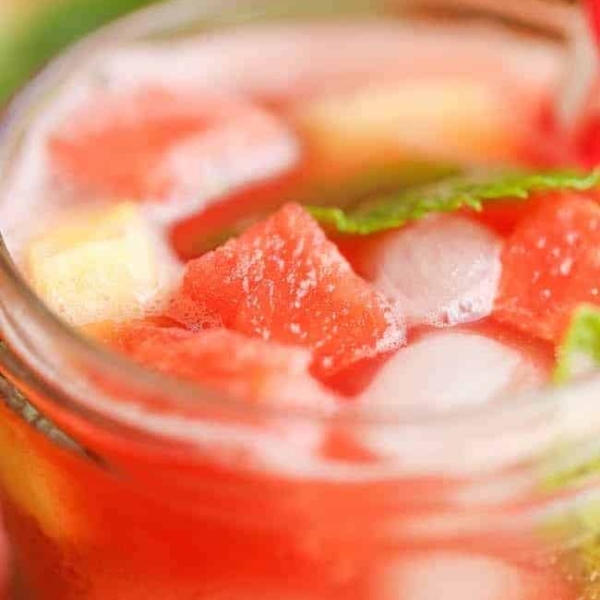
[554,304,600,384]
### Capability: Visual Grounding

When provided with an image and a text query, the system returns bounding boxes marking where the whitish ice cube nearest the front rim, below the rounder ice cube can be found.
[363,331,547,412]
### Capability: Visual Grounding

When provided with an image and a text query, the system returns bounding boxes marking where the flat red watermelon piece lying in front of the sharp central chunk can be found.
[112,322,333,407]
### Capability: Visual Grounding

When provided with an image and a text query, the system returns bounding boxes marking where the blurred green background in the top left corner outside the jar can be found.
[0,0,158,104]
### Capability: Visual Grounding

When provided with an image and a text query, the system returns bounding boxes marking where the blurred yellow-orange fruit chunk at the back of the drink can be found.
[295,79,519,168]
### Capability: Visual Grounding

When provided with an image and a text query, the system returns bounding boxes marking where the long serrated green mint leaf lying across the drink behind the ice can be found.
[308,170,600,235]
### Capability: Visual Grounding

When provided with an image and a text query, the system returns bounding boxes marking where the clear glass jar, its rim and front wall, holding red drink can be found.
[0,0,600,600]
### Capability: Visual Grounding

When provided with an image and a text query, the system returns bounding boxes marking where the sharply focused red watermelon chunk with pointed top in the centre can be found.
[176,204,405,377]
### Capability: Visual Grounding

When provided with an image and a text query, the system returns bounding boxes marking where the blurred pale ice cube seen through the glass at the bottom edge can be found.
[373,551,529,600]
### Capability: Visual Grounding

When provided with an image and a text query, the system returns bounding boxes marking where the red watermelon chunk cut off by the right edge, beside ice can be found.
[494,195,600,342]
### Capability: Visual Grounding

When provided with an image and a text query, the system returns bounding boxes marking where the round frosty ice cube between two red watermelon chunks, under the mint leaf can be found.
[365,215,501,327]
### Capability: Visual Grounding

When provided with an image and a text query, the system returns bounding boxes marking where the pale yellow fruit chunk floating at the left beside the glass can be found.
[26,203,169,327]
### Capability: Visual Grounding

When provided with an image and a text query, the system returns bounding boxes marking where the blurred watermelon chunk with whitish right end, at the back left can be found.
[48,87,298,209]
